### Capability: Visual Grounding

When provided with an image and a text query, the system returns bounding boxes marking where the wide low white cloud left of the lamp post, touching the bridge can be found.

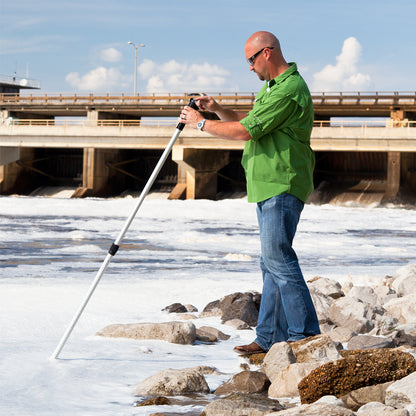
[65,66,128,92]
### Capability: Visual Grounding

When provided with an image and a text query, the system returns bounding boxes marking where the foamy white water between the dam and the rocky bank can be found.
[0,197,416,416]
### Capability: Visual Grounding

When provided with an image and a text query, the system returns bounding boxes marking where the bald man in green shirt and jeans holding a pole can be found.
[180,32,320,354]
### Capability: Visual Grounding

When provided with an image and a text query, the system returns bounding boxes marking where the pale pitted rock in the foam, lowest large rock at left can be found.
[133,369,209,396]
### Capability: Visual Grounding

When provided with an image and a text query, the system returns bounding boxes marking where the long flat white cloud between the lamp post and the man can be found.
[139,59,230,92]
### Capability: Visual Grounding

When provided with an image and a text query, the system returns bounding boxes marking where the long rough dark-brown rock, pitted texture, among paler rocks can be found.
[298,349,416,403]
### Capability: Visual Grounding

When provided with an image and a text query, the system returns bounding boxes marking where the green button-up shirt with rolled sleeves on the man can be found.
[240,63,315,202]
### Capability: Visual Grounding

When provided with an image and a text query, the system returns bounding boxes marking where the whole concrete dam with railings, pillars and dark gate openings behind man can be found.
[0,92,416,203]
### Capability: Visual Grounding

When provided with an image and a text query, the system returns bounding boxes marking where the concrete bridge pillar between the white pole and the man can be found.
[172,147,230,199]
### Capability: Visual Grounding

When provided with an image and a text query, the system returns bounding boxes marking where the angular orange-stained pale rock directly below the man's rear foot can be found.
[290,334,342,363]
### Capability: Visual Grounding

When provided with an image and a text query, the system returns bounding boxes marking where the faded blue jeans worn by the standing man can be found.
[255,194,320,350]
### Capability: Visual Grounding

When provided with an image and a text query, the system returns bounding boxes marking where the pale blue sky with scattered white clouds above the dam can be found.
[0,0,416,94]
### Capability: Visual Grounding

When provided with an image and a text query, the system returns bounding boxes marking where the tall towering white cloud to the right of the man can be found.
[312,37,371,91]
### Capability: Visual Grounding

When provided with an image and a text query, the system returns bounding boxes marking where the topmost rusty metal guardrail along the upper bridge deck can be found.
[0,92,416,106]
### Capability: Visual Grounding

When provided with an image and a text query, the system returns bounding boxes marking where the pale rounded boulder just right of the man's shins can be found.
[328,296,374,334]
